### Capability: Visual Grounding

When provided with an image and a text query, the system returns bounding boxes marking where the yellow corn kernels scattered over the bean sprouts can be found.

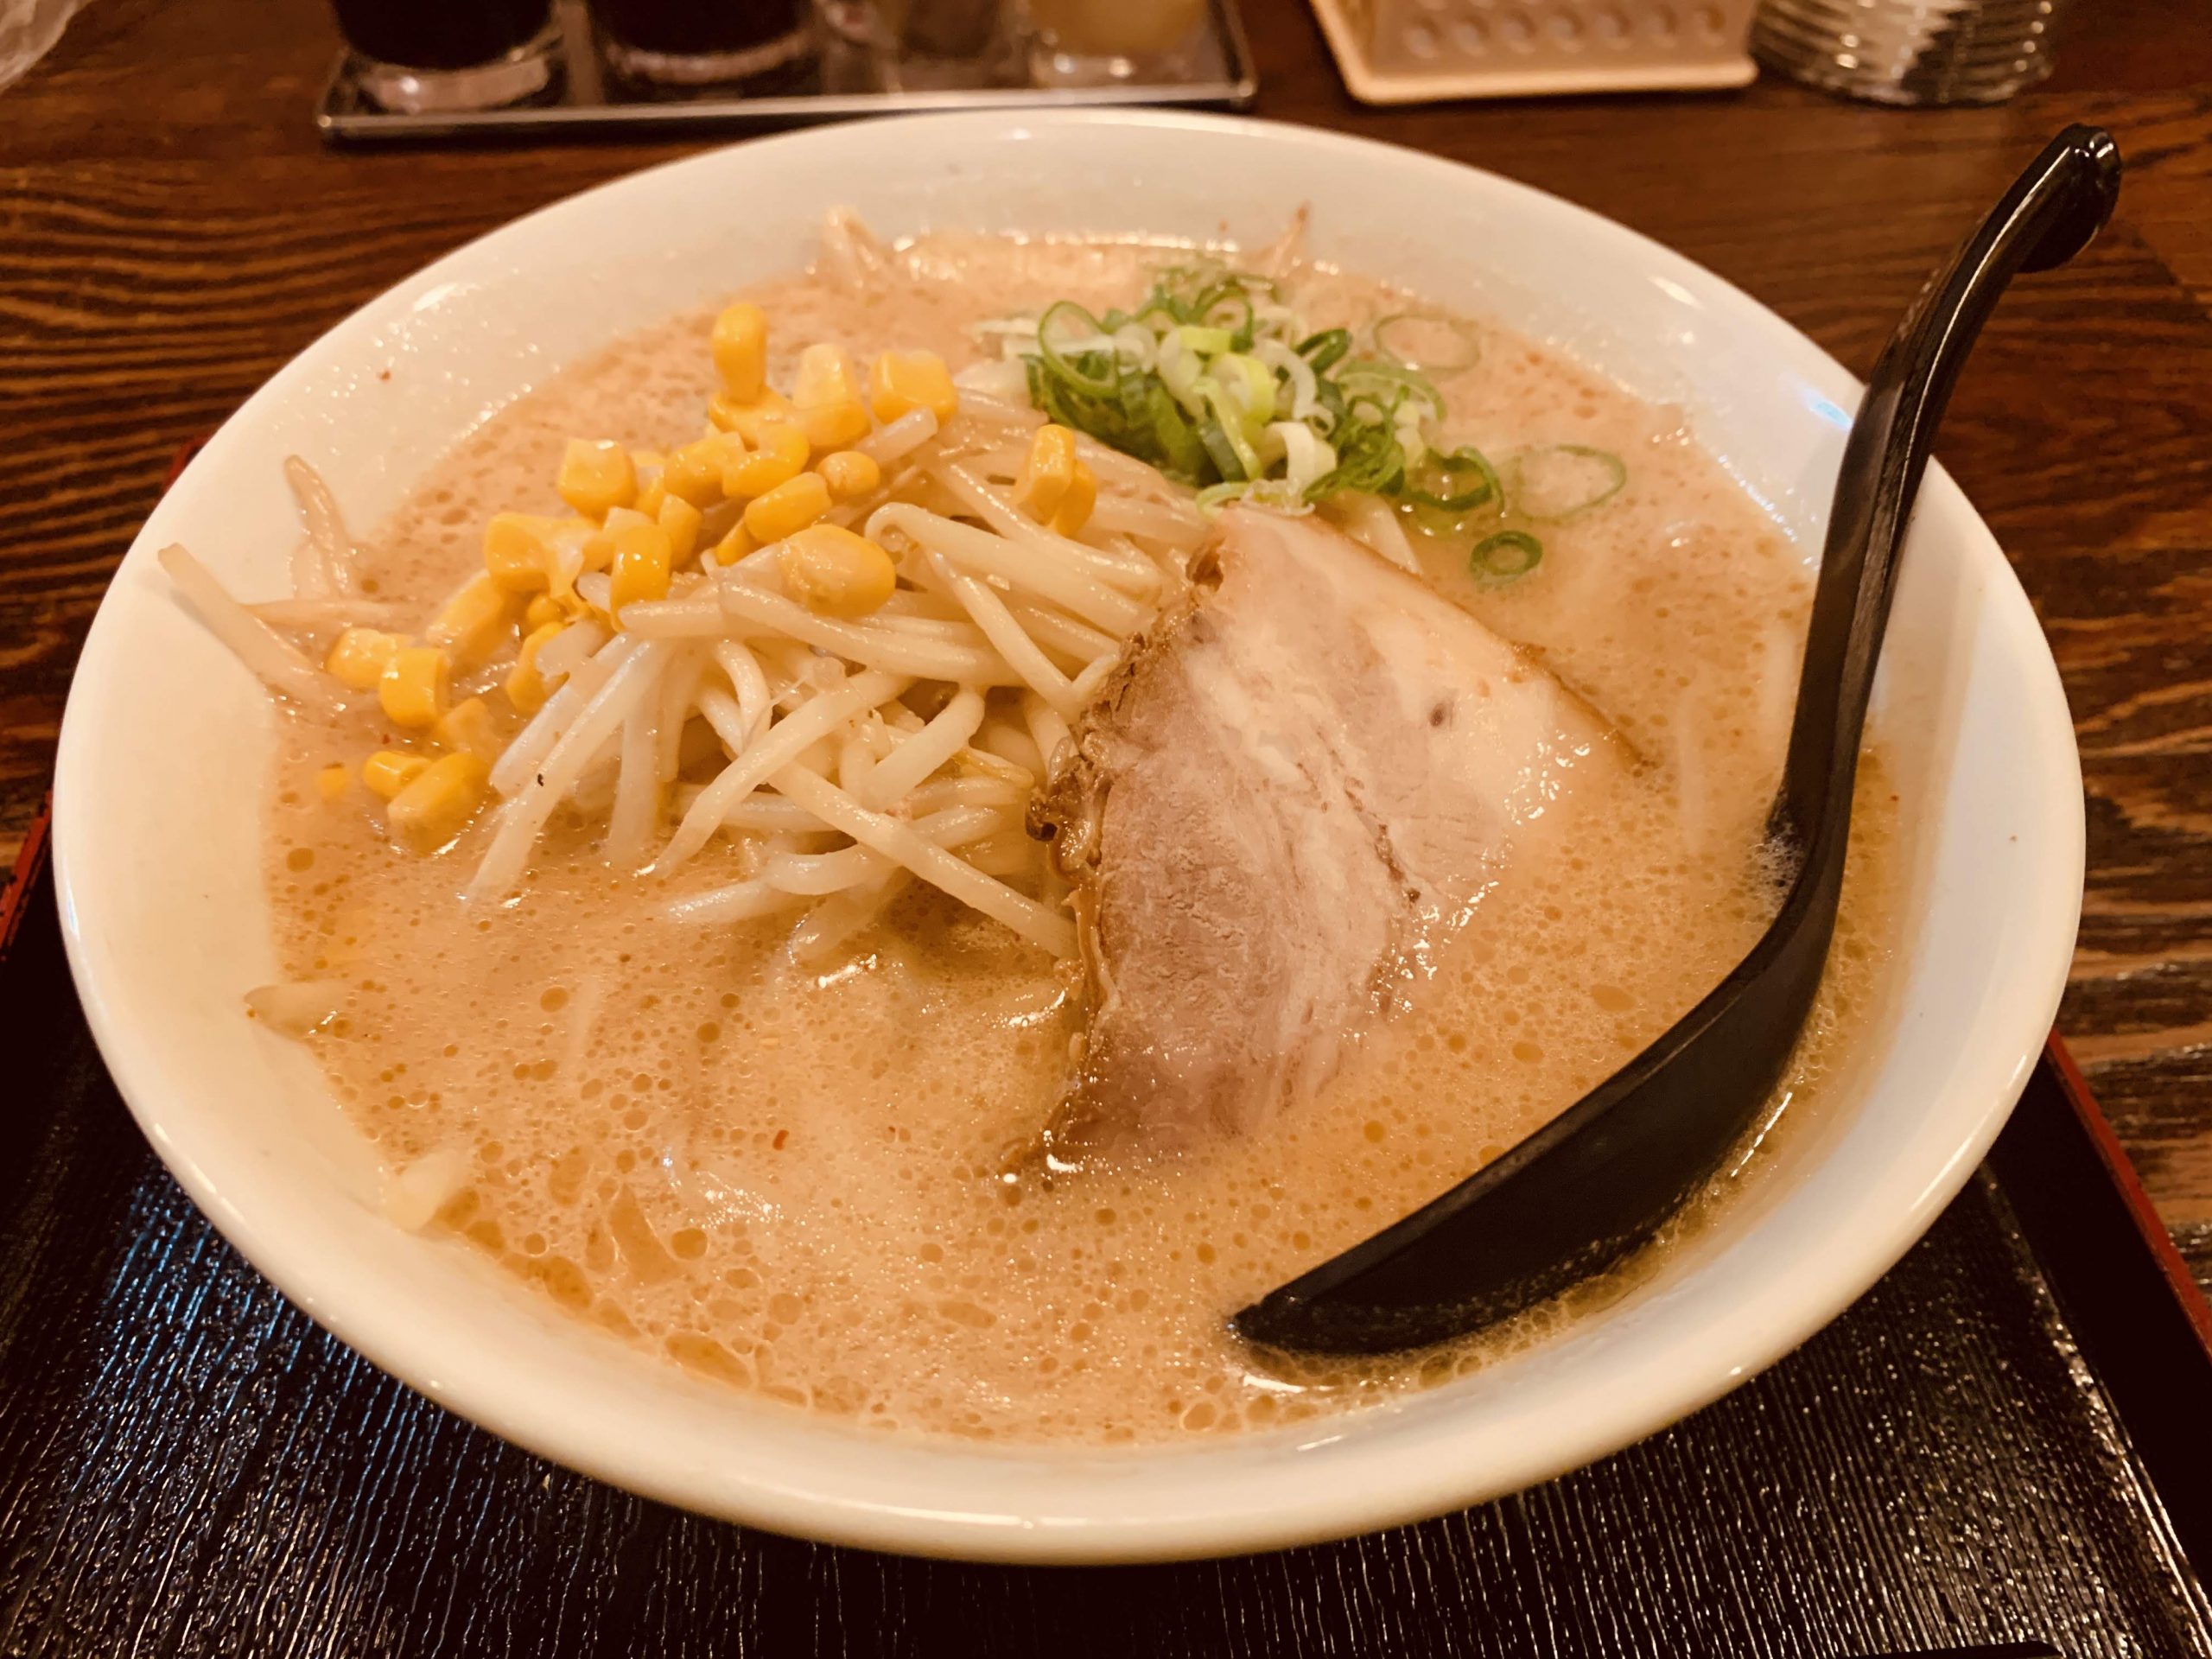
[323,303,1097,852]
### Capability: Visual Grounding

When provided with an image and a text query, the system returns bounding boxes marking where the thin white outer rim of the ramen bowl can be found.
[53,108,2084,1564]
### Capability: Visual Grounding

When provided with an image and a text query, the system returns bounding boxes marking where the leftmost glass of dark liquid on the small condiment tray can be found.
[332,0,560,113]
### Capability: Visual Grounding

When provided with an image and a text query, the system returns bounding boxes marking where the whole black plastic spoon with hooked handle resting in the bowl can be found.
[1232,126,2119,1354]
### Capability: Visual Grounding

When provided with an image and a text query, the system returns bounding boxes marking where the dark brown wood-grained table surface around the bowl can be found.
[0,0,2212,1281]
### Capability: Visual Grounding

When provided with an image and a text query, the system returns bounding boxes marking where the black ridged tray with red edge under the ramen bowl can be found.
[0,800,2212,1659]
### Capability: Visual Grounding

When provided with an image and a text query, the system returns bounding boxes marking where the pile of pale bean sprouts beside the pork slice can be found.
[162,314,1205,963]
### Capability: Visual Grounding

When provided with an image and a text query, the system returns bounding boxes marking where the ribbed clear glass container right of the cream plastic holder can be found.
[1752,0,2070,104]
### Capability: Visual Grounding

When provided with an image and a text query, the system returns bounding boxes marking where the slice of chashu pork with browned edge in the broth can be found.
[1033,509,1624,1157]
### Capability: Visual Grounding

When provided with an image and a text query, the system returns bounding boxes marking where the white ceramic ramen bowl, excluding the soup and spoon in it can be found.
[55,113,2082,1561]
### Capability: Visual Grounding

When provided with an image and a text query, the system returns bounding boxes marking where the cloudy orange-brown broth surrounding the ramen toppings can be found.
[270,237,1893,1442]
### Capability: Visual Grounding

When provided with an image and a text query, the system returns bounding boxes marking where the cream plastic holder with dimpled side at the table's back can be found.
[1300,0,1758,104]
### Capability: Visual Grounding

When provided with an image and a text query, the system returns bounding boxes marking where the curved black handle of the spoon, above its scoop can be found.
[1770,126,2119,868]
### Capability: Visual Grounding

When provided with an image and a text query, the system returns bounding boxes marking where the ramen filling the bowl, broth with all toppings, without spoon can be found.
[186,221,1893,1442]
